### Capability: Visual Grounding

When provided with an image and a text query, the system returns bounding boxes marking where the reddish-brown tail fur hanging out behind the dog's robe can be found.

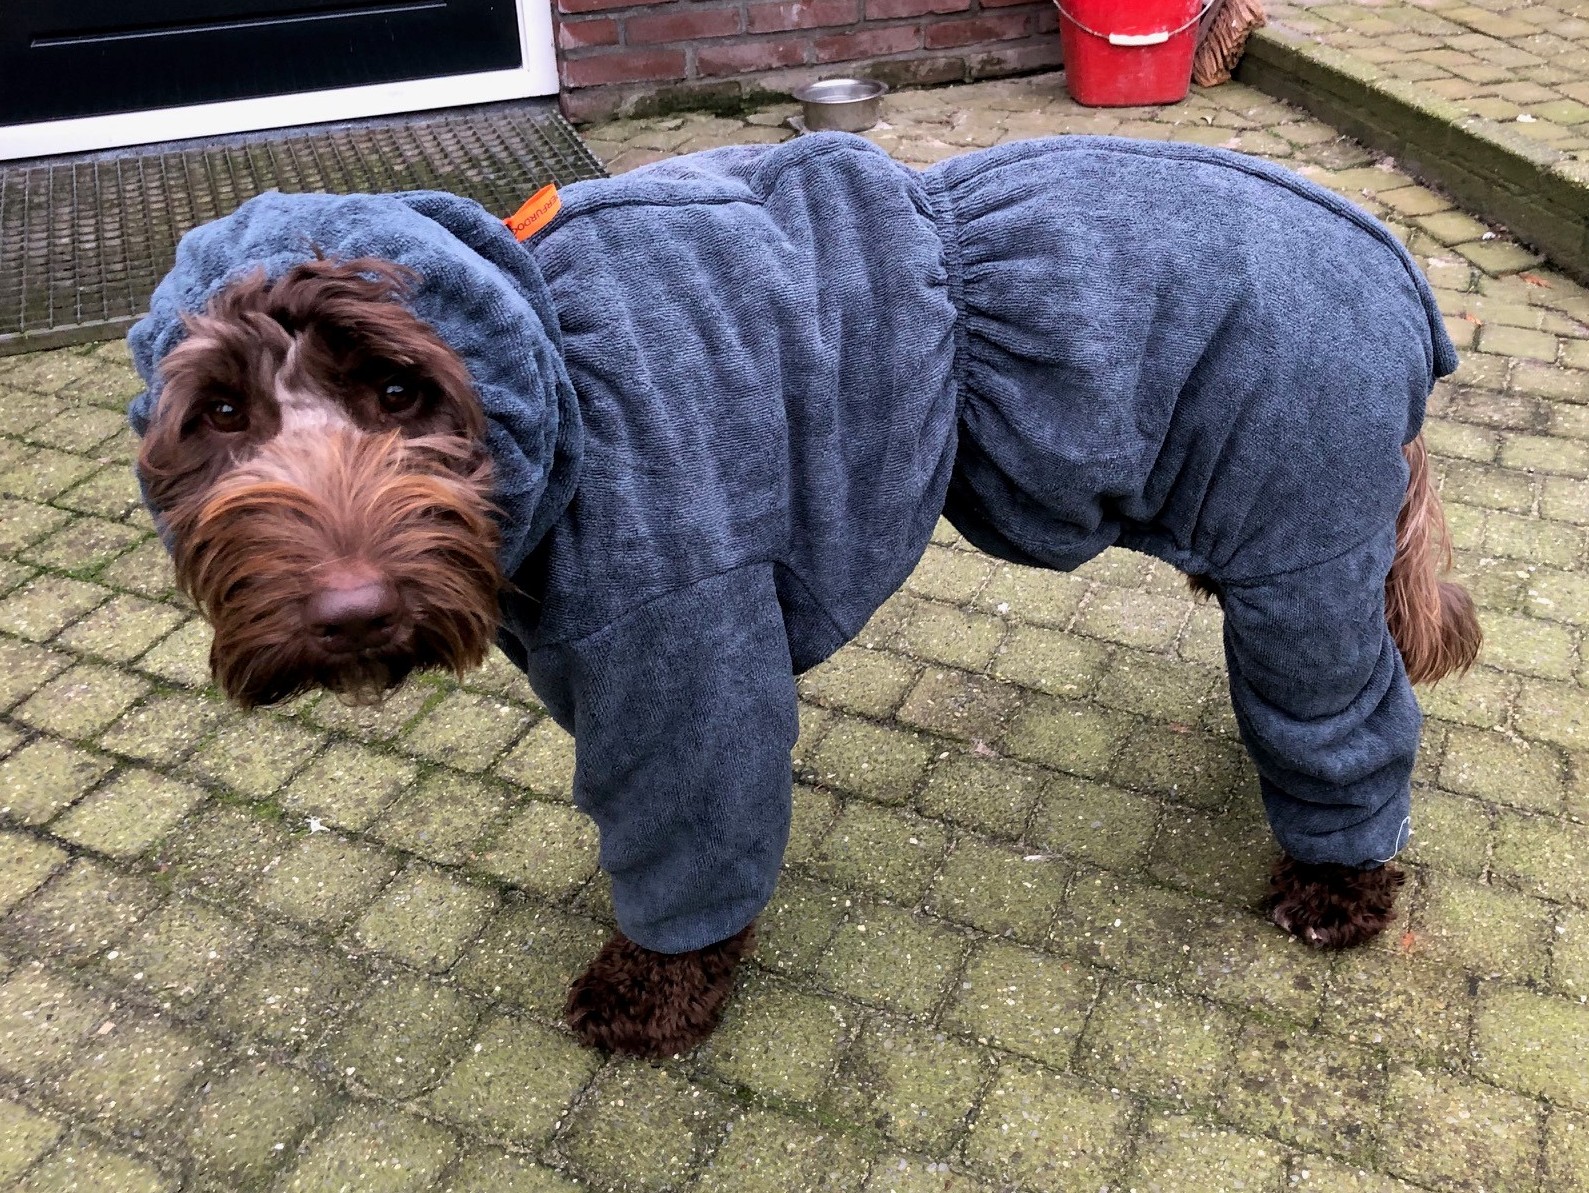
[1386,435,1484,683]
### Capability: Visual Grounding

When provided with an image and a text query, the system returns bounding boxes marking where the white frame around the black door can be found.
[0,0,558,160]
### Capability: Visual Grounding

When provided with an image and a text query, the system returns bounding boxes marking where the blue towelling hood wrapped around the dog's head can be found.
[127,191,582,575]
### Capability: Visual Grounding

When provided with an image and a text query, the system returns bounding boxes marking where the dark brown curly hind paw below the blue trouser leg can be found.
[1268,855,1406,948]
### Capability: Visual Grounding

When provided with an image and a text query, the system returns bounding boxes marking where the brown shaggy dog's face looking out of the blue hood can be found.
[138,259,502,705]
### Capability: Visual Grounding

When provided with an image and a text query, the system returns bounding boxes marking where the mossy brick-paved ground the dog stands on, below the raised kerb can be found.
[0,78,1589,1193]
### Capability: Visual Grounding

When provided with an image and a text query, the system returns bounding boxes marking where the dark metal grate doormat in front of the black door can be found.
[0,103,605,354]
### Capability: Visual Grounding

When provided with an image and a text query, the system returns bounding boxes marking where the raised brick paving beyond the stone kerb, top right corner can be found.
[1266,0,1589,160]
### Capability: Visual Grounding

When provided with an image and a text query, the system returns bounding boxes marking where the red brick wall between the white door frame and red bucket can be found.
[555,0,1060,119]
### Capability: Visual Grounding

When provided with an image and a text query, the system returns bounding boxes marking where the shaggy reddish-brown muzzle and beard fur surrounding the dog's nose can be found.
[172,435,501,707]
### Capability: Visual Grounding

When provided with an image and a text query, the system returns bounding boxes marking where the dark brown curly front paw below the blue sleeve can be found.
[563,925,756,1058]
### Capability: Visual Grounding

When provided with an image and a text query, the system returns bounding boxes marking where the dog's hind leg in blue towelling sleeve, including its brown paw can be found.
[1219,527,1422,947]
